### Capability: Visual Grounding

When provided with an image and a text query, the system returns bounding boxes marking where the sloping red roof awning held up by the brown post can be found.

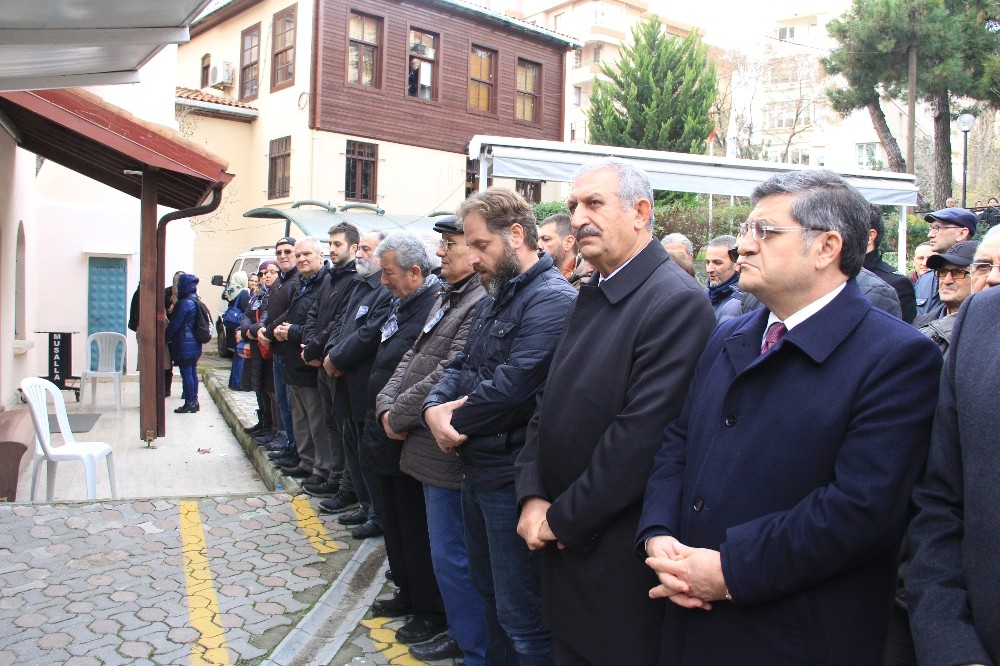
[0,89,233,209]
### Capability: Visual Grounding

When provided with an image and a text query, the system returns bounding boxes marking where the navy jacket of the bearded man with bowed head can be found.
[422,254,576,490]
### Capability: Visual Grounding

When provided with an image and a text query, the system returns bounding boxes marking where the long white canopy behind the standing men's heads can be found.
[469,135,917,272]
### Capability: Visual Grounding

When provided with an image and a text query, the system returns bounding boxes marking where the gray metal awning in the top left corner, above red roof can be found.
[0,0,210,90]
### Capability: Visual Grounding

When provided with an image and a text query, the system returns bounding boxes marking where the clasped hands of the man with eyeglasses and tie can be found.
[646,536,729,610]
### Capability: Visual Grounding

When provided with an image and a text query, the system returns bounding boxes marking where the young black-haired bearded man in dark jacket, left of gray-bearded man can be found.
[292,222,361,497]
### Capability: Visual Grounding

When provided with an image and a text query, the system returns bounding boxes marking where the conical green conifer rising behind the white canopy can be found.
[588,16,716,154]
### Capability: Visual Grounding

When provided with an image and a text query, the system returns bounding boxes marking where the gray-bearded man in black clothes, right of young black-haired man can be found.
[319,231,392,539]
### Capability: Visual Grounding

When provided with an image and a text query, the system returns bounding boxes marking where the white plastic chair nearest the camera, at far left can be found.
[21,377,118,502]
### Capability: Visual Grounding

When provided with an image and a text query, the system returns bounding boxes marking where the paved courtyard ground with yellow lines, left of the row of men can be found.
[0,358,462,666]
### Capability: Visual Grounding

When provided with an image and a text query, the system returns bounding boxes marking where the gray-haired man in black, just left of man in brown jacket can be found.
[361,232,446,643]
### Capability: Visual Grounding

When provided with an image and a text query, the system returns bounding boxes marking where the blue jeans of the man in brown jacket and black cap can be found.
[424,483,486,666]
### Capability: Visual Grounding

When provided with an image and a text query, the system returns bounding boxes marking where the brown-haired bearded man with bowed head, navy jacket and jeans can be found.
[423,188,576,664]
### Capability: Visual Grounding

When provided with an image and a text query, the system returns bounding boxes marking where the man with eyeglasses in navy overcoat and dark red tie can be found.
[635,170,941,666]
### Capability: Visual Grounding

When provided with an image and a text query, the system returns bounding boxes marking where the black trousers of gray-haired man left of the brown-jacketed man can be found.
[379,474,444,622]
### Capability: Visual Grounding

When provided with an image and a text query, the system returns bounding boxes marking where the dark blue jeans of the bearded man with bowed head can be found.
[462,480,553,666]
